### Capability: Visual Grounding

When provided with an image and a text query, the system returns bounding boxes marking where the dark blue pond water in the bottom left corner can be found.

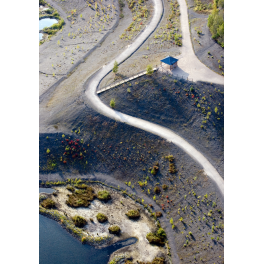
[39,188,137,264]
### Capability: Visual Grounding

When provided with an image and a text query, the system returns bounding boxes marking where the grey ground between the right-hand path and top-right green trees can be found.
[187,0,224,74]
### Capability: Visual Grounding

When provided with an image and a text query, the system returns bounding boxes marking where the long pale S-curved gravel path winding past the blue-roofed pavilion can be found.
[84,0,224,263]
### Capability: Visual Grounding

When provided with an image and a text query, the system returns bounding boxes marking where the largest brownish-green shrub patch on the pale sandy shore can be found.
[66,185,96,207]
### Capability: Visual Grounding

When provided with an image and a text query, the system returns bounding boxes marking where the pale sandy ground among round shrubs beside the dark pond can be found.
[49,185,166,261]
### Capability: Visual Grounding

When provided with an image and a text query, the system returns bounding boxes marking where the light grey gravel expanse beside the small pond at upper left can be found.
[39,0,119,95]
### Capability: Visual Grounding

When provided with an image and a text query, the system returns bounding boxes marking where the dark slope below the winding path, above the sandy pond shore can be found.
[39,94,223,263]
